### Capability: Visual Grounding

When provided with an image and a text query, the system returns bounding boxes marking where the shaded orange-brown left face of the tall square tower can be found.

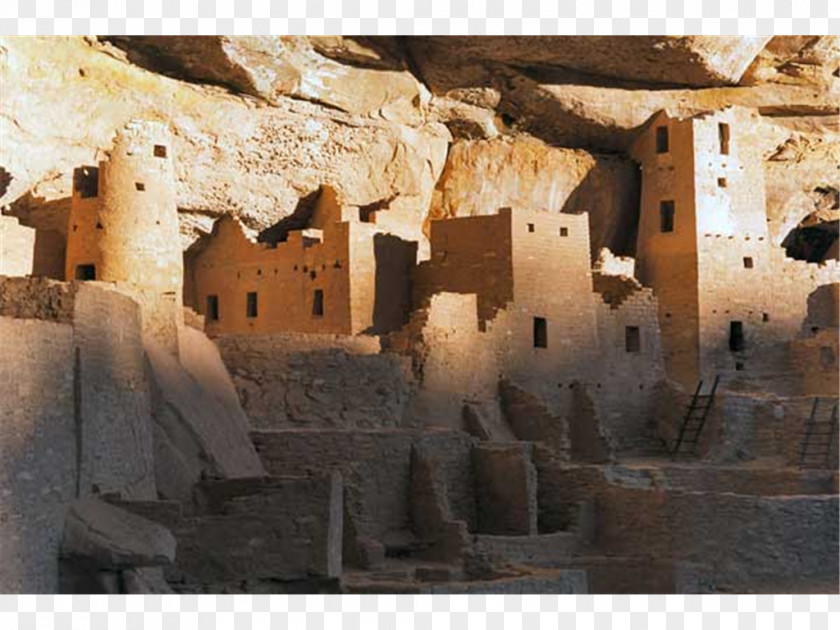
[632,112,699,386]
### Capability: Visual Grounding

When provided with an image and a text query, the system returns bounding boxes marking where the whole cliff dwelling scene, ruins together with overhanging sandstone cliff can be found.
[0,36,840,594]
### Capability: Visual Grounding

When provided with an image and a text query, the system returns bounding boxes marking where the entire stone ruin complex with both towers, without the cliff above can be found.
[0,115,838,593]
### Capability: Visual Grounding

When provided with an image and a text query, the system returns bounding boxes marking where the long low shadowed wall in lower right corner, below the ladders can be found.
[536,458,838,590]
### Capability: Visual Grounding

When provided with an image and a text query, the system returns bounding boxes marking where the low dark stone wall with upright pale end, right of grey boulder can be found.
[117,472,343,592]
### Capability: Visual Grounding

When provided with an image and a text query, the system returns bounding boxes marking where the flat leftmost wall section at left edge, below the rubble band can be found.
[0,316,77,593]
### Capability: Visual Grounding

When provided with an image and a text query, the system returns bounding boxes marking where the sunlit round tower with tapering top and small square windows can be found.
[65,121,183,353]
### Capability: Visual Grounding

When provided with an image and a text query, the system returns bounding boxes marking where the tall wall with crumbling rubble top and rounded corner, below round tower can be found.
[0,278,155,592]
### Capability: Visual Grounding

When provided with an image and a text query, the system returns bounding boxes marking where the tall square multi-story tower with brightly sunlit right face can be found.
[631,107,825,387]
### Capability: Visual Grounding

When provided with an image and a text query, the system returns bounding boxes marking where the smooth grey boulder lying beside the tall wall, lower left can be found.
[62,499,175,569]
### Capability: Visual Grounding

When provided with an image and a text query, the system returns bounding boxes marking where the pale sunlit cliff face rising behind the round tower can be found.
[0,38,450,246]
